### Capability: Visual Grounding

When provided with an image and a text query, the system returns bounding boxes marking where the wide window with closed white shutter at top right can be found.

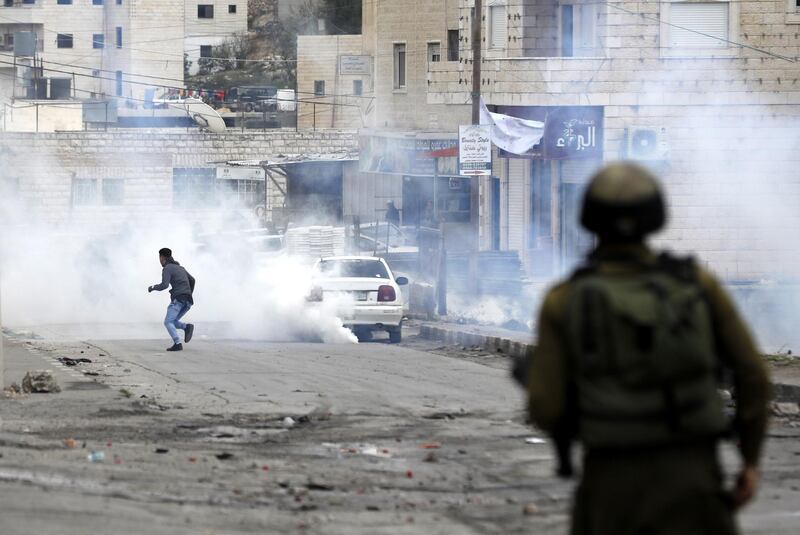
[669,2,728,48]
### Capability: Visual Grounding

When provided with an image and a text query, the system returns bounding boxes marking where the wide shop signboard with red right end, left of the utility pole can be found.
[359,135,458,176]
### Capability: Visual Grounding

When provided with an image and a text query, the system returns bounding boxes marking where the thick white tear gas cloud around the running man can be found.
[0,197,356,343]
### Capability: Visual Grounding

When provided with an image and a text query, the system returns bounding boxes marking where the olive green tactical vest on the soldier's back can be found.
[567,255,728,449]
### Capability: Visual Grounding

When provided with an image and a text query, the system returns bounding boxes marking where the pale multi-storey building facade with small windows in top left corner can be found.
[0,0,247,107]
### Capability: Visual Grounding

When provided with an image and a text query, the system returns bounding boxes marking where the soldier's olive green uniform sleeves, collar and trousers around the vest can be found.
[528,245,769,535]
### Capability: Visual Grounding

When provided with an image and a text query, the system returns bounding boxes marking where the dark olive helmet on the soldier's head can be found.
[581,162,666,241]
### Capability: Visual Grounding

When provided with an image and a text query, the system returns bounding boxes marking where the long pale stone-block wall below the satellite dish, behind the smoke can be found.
[0,130,358,226]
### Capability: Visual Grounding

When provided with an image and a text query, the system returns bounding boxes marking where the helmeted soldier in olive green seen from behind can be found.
[528,163,769,535]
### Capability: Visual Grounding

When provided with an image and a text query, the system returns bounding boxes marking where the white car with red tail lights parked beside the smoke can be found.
[307,256,408,344]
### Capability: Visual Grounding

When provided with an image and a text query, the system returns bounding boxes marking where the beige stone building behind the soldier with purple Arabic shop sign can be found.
[296,0,800,284]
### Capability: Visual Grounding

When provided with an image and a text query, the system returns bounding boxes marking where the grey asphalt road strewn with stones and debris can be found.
[0,325,800,535]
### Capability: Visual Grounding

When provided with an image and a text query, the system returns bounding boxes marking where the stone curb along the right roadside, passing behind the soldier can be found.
[419,325,800,403]
